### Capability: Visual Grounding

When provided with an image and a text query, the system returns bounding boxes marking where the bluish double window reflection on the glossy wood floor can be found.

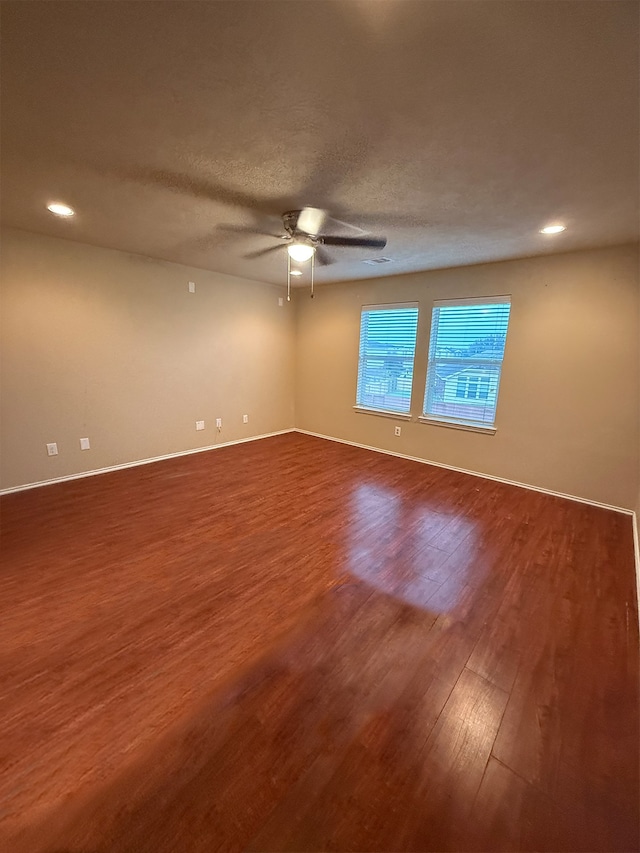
[347,483,477,612]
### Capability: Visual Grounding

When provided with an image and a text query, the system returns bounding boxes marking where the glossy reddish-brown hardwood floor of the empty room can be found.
[0,434,640,853]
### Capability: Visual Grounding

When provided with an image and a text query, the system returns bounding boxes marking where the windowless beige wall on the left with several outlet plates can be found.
[0,229,294,488]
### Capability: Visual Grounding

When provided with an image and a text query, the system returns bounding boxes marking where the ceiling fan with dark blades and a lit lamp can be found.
[245,207,387,266]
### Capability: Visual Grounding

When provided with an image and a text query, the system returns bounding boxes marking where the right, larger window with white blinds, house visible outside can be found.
[423,296,511,428]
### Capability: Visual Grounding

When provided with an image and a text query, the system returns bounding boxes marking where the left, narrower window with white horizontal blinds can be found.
[356,304,418,414]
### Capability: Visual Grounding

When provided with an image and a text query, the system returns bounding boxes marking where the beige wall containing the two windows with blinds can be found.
[296,241,640,508]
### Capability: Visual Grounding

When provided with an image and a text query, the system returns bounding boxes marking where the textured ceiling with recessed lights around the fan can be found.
[1,0,640,283]
